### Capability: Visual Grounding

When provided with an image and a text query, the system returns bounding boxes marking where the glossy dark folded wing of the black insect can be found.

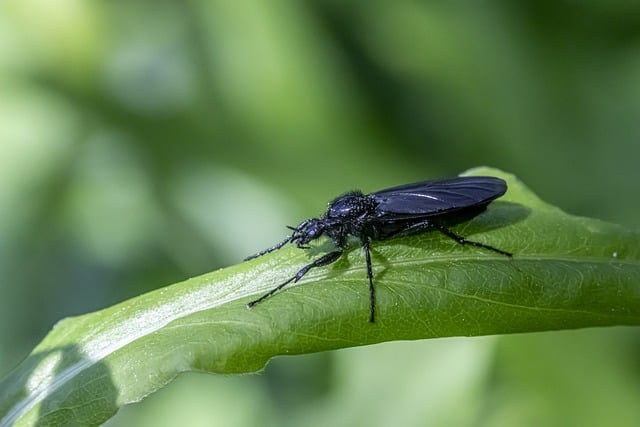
[370,176,507,219]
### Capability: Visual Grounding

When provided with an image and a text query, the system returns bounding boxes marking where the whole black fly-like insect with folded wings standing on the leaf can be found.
[246,176,512,322]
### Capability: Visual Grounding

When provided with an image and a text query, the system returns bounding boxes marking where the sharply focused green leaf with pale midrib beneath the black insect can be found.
[0,168,640,426]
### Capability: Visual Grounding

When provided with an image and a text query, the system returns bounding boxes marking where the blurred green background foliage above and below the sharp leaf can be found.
[0,0,640,426]
